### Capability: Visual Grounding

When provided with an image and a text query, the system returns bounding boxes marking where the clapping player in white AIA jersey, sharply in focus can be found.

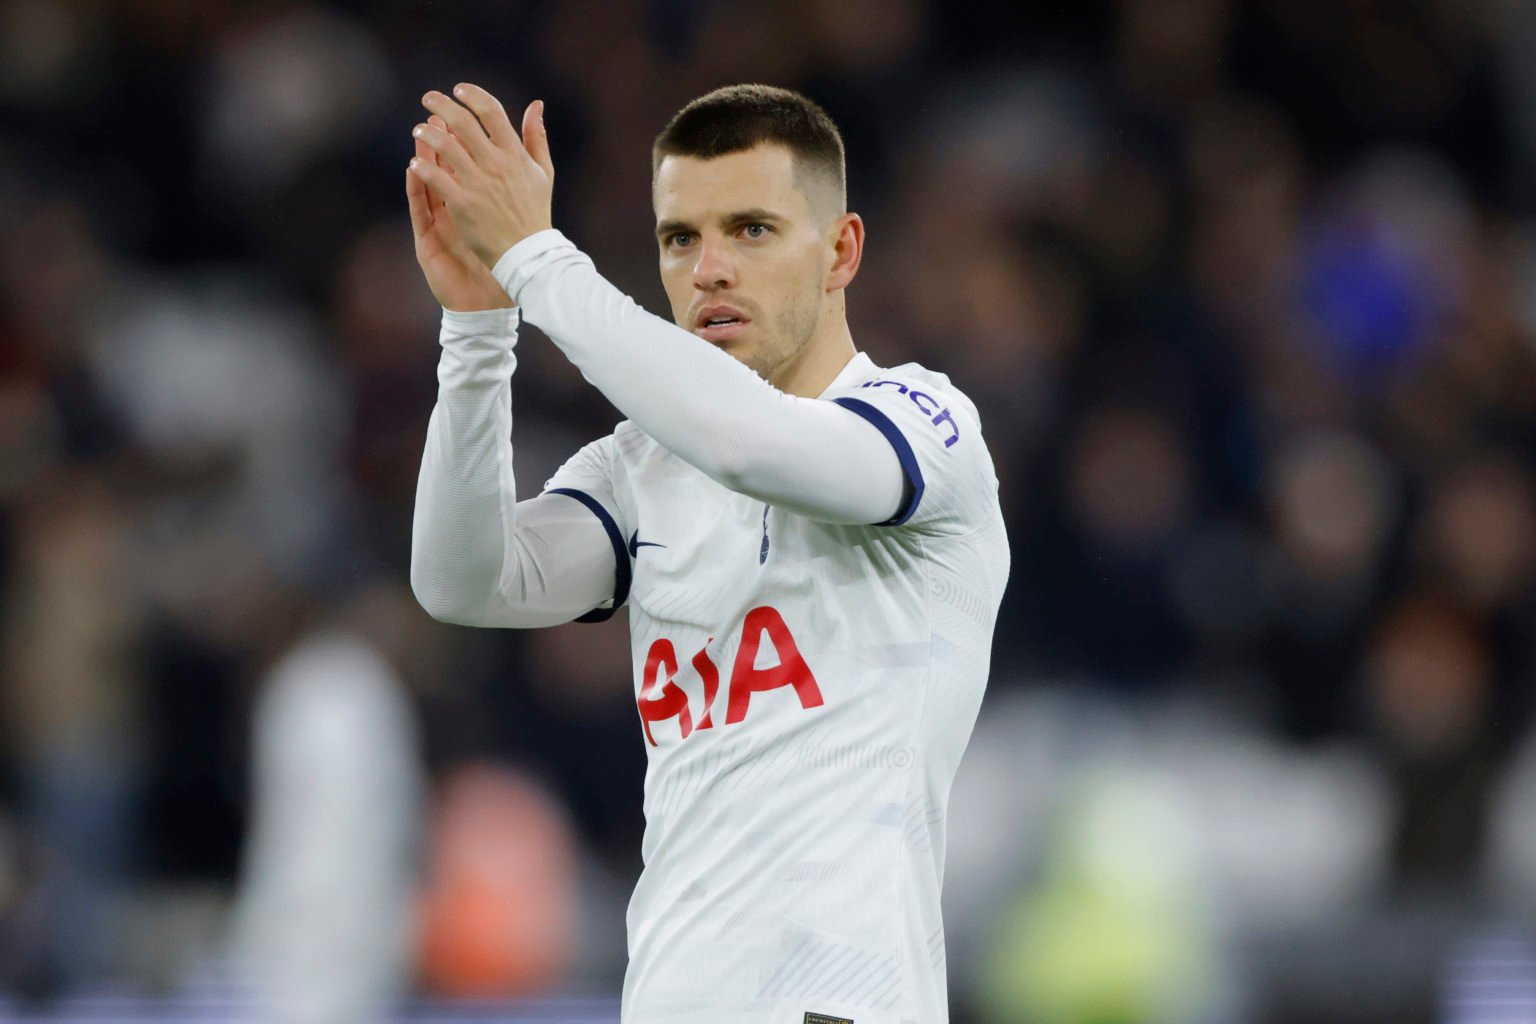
[407,84,1008,1024]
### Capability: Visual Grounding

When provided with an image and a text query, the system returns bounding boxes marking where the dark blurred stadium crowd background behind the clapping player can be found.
[0,0,1536,1024]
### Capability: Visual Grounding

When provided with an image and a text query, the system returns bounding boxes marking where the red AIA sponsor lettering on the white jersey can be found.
[636,605,825,746]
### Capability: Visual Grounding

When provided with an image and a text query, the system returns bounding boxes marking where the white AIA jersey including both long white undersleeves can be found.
[412,232,1009,1024]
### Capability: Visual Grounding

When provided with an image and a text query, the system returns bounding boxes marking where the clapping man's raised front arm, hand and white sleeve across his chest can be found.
[412,84,917,524]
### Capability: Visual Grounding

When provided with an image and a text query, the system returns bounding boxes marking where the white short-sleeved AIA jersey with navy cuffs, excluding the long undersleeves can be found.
[545,348,1009,1024]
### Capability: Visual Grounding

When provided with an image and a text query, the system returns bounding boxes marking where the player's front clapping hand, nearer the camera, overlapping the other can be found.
[410,83,554,267]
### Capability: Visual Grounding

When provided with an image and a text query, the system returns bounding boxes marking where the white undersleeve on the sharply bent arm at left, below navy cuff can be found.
[410,310,628,626]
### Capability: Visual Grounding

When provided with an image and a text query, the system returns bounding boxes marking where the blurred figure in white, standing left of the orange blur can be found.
[235,586,422,1024]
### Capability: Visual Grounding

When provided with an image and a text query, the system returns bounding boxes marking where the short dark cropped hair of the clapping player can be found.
[651,83,848,213]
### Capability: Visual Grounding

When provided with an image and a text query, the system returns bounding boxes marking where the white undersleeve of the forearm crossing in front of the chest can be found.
[493,230,914,524]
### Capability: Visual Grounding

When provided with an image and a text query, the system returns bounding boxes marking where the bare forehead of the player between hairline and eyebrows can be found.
[653,143,806,220]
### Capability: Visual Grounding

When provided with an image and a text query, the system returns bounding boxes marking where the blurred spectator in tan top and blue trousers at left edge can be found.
[3,470,144,986]
